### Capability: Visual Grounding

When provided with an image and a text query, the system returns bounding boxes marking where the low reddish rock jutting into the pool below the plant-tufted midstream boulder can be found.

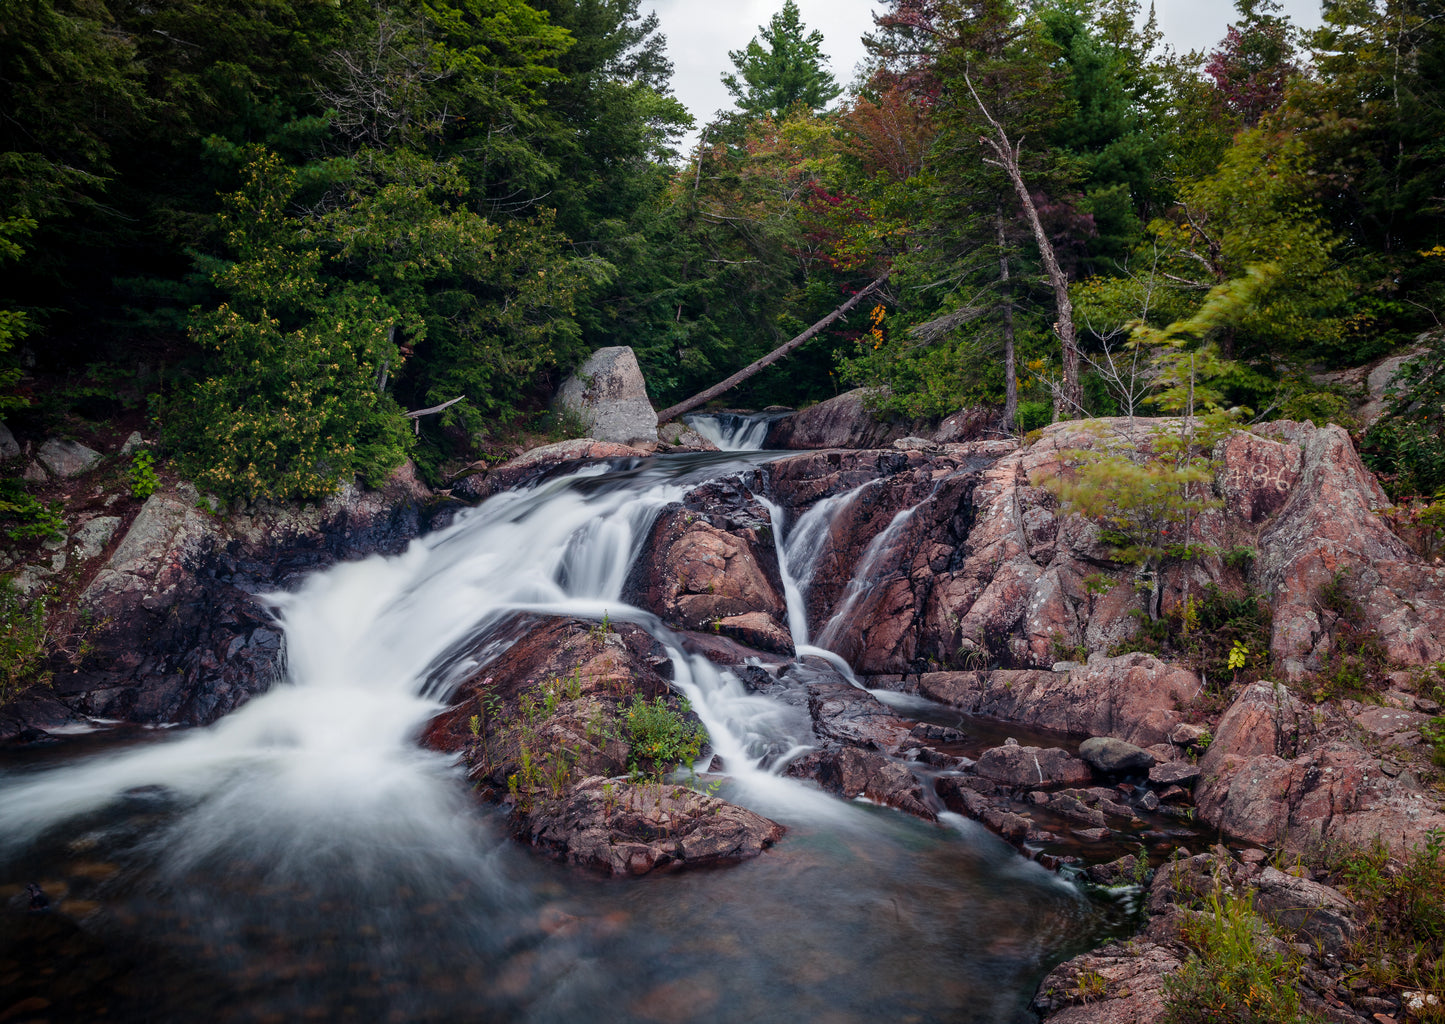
[516,777,783,875]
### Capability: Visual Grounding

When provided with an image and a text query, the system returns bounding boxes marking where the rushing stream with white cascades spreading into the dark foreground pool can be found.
[0,454,1121,1024]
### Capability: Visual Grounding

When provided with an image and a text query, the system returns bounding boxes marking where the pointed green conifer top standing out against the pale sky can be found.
[723,0,842,117]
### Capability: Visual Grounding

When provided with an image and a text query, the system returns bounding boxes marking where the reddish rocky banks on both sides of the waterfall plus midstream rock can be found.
[3,410,1445,1021]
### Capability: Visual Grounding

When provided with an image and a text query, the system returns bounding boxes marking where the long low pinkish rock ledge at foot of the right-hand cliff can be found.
[918,654,1199,744]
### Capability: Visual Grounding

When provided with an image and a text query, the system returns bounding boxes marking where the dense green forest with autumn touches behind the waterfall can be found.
[0,0,1445,508]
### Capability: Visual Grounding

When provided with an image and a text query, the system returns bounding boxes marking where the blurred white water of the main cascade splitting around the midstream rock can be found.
[0,456,861,861]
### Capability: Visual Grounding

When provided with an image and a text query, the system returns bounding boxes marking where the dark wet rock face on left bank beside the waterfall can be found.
[26,471,425,732]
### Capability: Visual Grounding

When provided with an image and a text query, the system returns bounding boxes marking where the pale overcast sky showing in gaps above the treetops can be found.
[642,0,1319,152]
